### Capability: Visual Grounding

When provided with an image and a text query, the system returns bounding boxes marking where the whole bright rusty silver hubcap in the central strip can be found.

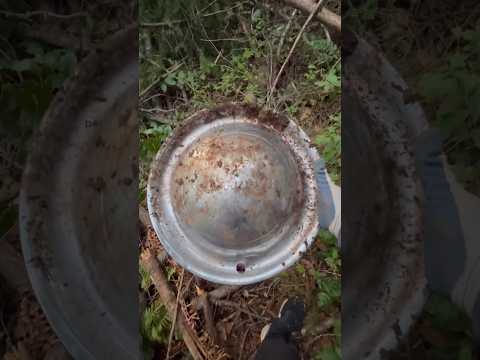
[148,105,319,284]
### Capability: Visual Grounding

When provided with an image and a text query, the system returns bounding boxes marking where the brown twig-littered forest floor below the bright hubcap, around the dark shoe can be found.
[144,228,338,360]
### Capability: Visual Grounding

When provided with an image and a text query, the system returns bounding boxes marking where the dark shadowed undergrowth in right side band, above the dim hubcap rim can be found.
[344,0,480,195]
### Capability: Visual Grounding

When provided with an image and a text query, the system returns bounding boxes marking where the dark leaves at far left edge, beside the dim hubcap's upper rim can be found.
[0,39,77,167]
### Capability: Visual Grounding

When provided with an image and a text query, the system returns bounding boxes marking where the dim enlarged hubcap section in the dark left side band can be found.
[20,27,141,360]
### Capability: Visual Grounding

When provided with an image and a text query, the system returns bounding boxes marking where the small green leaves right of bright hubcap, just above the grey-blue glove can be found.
[314,113,342,183]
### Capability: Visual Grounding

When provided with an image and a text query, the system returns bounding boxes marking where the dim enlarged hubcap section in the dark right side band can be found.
[342,35,426,359]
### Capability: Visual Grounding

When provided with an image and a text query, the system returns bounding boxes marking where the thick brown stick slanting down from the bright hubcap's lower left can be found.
[140,249,203,360]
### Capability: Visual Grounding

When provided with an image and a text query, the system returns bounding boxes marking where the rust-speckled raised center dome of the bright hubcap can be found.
[171,127,302,249]
